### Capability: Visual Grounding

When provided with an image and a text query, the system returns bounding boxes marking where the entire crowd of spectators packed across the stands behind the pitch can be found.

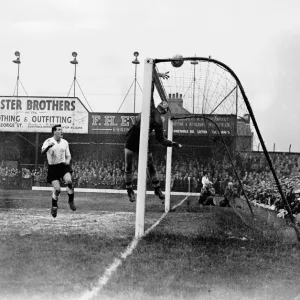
[0,147,300,219]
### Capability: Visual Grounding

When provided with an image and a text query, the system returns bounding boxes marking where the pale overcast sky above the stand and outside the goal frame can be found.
[0,0,300,152]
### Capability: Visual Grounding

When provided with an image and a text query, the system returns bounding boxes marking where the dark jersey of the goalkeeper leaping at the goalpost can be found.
[125,107,172,152]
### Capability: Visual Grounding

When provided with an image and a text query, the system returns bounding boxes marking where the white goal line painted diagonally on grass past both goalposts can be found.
[79,196,188,300]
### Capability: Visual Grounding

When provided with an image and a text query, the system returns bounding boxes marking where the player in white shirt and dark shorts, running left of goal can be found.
[42,125,76,218]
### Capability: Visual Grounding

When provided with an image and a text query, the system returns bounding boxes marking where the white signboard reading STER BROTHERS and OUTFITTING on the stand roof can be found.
[0,96,89,133]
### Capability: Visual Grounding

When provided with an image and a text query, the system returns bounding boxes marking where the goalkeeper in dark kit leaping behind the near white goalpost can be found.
[125,99,182,202]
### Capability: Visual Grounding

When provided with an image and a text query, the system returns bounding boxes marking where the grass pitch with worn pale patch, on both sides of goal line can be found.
[0,191,300,300]
